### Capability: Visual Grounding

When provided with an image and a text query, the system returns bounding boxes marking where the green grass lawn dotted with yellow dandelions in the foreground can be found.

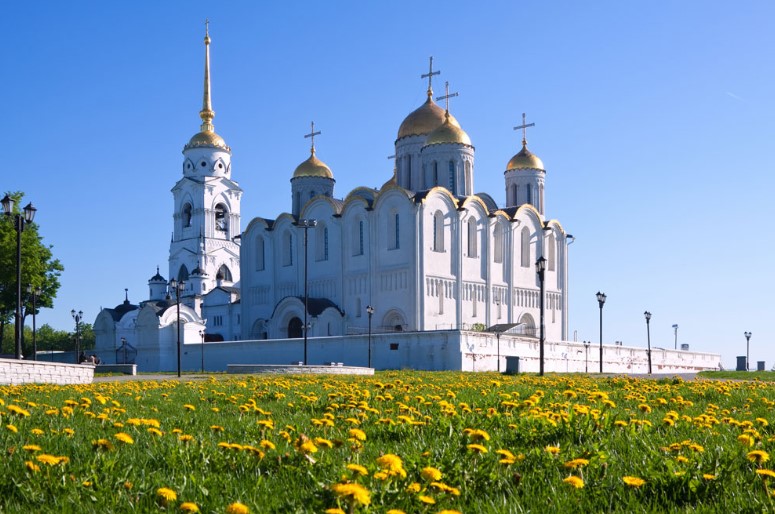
[0,371,775,513]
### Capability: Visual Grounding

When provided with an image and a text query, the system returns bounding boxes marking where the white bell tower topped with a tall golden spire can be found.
[169,23,242,306]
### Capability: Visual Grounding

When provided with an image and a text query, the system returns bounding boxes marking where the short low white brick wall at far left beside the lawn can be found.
[0,359,94,385]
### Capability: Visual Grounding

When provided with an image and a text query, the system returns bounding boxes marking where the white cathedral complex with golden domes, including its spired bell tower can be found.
[94,30,573,370]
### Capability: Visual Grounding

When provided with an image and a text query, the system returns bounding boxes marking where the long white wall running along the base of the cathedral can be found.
[165,330,721,373]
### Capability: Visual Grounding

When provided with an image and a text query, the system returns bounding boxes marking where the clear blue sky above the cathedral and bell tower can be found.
[0,0,775,368]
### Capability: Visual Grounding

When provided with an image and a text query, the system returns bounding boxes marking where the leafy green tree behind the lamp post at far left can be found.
[0,192,64,353]
